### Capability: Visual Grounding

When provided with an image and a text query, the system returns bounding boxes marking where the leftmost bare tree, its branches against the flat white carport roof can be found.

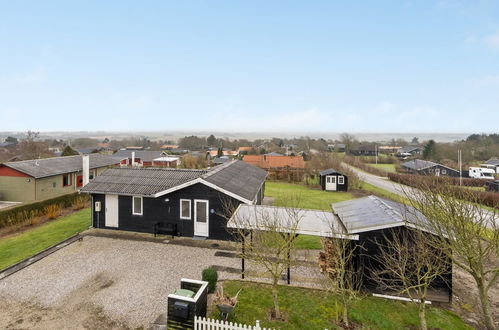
[228,206,303,319]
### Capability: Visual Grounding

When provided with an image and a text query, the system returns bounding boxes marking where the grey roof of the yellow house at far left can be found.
[3,154,119,178]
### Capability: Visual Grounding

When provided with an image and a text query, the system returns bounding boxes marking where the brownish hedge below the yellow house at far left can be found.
[0,193,89,228]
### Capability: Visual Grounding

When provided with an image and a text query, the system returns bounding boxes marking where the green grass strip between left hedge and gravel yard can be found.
[0,209,90,269]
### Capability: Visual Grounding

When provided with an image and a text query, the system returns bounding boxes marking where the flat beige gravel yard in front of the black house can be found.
[0,236,240,329]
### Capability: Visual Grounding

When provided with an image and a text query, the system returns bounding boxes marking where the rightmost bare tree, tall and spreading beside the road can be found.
[406,184,499,329]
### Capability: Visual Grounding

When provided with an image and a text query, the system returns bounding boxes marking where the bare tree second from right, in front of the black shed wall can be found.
[370,228,452,330]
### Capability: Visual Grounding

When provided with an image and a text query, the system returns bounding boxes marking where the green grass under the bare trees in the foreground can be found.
[211,281,470,329]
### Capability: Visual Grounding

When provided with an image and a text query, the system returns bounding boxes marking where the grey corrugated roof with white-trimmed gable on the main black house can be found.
[81,160,267,203]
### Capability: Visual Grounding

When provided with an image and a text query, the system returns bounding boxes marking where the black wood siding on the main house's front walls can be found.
[92,183,264,240]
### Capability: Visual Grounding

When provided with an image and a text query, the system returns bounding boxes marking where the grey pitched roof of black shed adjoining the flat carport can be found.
[331,195,427,234]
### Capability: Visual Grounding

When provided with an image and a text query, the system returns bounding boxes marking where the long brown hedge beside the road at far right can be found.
[388,173,499,208]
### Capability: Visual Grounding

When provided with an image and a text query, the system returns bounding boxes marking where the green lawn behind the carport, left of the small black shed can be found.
[265,181,353,249]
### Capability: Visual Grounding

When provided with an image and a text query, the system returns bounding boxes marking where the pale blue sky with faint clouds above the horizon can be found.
[0,0,499,133]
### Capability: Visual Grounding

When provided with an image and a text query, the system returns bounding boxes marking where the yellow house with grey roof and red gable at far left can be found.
[0,154,118,202]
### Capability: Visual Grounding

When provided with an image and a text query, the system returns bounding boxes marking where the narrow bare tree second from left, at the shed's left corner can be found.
[319,236,363,327]
